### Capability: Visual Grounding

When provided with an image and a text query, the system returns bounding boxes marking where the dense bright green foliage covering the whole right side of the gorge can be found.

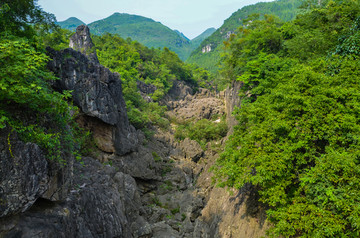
[216,0,360,237]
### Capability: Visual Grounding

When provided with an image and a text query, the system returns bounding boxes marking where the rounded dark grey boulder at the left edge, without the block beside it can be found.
[0,129,49,217]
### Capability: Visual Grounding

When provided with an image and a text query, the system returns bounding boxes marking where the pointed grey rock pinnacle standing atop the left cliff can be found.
[69,25,99,63]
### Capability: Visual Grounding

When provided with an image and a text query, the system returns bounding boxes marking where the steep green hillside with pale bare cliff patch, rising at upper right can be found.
[187,0,302,72]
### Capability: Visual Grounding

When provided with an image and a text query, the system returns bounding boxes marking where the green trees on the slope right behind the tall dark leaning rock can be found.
[93,34,209,132]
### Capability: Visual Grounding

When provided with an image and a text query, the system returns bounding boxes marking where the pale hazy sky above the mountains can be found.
[38,0,271,39]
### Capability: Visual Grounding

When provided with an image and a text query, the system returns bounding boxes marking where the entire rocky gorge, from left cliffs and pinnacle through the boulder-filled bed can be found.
[0,26,268,238]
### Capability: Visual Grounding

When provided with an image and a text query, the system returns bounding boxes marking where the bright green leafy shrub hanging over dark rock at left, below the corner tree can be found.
[0,37,83,160]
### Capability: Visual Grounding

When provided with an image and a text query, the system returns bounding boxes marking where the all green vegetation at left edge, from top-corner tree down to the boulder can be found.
[0,0,82,162]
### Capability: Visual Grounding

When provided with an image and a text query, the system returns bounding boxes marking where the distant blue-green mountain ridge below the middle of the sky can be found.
[58,13,213,60]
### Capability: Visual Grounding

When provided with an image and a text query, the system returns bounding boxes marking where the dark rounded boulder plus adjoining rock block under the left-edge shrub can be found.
[0,129,72,218]
